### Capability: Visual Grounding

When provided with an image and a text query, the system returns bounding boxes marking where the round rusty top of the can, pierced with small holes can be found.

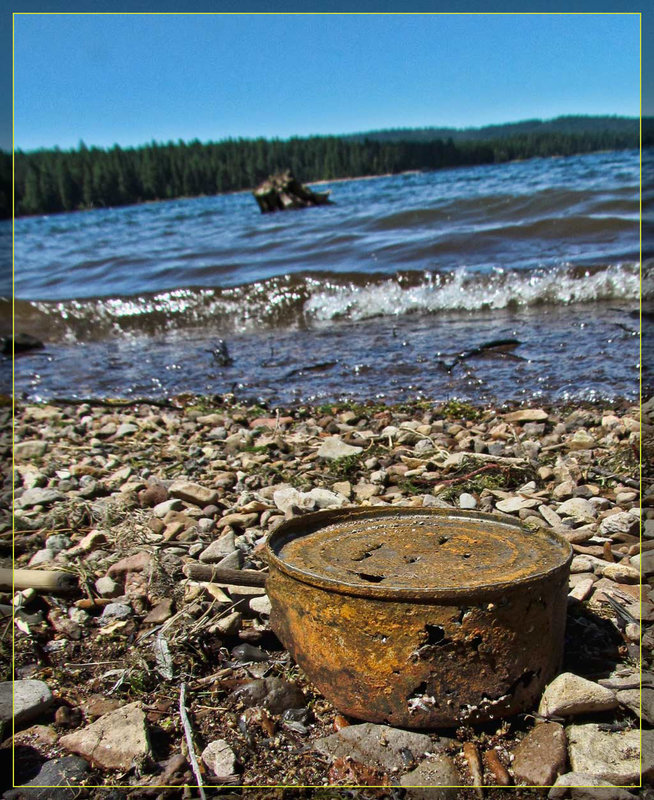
[268,507,572,599]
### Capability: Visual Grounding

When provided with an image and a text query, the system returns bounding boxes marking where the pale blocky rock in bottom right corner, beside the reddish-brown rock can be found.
[566,723,645,785]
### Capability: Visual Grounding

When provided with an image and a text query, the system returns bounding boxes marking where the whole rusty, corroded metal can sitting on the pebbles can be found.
[267,508,572,727]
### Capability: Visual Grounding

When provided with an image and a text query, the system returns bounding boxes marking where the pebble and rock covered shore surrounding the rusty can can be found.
[0,396,654,800]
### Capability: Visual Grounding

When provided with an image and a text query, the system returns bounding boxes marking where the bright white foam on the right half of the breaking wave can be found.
[304,264,640,322]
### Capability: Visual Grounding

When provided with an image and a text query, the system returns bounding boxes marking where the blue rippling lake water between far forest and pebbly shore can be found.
[5,151,654,405]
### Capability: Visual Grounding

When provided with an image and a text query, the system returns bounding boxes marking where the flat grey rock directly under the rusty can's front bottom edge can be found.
[313,722,434,771]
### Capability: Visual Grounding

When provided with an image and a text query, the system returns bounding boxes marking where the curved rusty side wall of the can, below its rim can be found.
[266,564,568,728]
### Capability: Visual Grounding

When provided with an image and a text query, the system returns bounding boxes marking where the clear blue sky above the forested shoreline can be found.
[10,14,651,150]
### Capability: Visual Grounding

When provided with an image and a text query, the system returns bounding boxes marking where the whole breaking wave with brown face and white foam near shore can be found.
[6,262,654,341]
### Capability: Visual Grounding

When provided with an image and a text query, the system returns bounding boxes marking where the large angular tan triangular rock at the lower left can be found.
[59,703,151,772]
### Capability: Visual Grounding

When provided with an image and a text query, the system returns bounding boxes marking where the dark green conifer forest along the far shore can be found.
[0,122,652,217]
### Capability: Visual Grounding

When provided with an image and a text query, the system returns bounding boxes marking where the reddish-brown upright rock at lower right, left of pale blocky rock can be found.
[513,722,568,786]
